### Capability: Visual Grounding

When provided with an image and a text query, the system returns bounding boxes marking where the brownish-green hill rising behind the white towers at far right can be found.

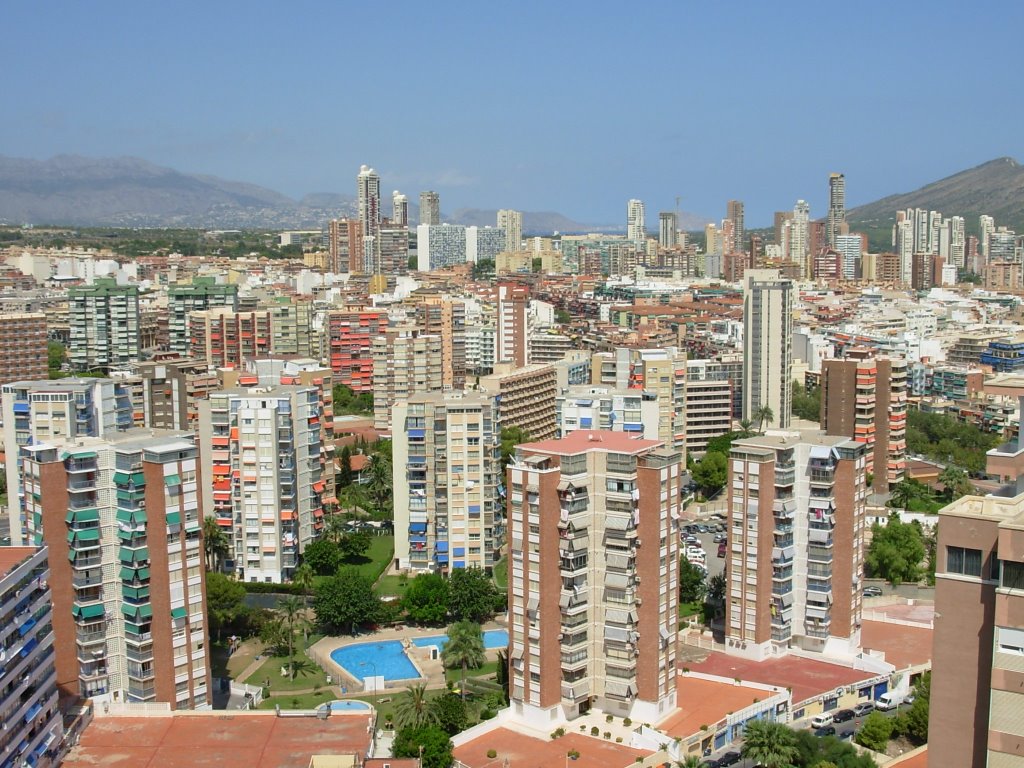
[847,158,1024,232]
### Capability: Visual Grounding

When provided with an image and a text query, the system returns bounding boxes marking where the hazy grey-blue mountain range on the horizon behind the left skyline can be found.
[0,155,707,234]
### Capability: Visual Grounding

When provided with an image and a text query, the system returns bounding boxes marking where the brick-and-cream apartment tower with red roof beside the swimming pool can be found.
[508,430,682,727]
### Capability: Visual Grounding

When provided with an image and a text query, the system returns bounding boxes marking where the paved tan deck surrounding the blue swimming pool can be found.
[308,622,508,695]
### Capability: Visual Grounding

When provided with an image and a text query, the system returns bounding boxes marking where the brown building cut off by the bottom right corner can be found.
[928,496,1024,768]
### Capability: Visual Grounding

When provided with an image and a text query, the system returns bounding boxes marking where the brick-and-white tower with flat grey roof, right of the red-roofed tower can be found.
[725,431,867,659]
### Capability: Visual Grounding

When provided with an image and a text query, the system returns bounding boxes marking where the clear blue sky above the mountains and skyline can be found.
[0,0,1024,226]
